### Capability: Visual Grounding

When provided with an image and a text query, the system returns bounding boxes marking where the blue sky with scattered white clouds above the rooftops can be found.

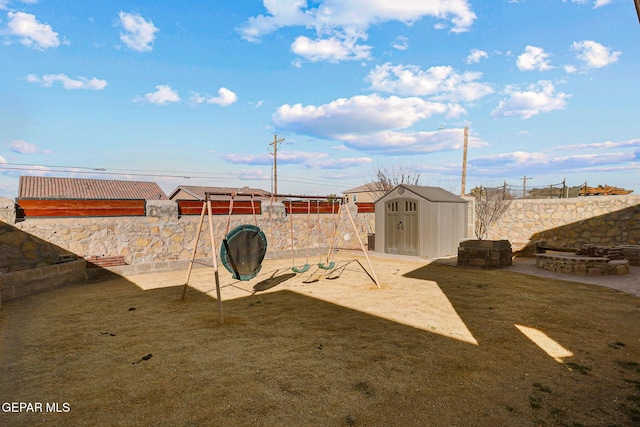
[0,0,640,198]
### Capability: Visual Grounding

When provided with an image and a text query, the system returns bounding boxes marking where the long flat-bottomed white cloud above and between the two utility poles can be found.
[273,94,451,138]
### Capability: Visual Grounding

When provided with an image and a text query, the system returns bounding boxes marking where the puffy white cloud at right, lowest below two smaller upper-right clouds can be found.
[491,80,571,119]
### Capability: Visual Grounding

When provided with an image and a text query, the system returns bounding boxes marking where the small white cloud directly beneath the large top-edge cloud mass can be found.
[291,32,371,63]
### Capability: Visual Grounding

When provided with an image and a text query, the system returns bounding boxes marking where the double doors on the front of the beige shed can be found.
[385,199,420,256]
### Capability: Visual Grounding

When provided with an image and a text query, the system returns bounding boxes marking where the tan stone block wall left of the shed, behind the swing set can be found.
[0,201,374,272]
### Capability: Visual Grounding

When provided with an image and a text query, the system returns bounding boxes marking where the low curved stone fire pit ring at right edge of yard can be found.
[534,253,629,276]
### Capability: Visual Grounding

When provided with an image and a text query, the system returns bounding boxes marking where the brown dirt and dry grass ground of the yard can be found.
[0,252,640,426]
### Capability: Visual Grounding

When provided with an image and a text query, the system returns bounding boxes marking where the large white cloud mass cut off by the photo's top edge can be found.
[238,0,476,62]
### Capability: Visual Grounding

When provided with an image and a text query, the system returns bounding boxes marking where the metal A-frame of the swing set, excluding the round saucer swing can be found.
[181,191,380,323]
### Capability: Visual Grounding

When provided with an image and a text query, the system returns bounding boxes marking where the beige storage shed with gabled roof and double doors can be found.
[375,184,468,258]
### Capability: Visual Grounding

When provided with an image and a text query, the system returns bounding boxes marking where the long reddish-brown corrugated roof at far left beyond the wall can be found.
[18,176,169,200]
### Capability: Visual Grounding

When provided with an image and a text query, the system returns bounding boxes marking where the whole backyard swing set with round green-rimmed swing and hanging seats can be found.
[182,192,380,323]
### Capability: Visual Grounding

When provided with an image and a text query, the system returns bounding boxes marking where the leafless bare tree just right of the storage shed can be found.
[471,183,513,240]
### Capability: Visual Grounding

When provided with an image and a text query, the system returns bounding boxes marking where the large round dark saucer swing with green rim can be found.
[220,224,267,280]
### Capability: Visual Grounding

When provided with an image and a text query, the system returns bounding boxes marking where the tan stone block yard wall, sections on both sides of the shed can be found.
[0,196,640,272]
